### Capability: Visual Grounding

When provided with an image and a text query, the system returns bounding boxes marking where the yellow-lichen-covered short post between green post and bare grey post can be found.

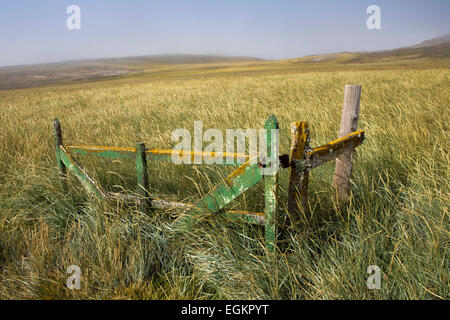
[288,121,309,222]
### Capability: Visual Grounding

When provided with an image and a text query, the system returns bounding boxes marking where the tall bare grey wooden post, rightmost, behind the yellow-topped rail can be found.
[333,84,361,201]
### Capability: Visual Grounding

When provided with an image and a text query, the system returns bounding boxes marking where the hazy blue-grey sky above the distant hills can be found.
[0,0,450,66]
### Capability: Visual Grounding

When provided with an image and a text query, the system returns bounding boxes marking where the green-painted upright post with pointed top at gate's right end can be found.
[264,115,279,252]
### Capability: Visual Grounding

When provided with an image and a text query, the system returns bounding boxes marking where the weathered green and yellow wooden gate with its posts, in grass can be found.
[53,85,364,252]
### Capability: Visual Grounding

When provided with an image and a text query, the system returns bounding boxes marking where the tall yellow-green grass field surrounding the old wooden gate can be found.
[0,55,450,299]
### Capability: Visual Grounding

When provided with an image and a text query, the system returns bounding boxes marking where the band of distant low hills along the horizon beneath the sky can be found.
[0,35,450,90]
